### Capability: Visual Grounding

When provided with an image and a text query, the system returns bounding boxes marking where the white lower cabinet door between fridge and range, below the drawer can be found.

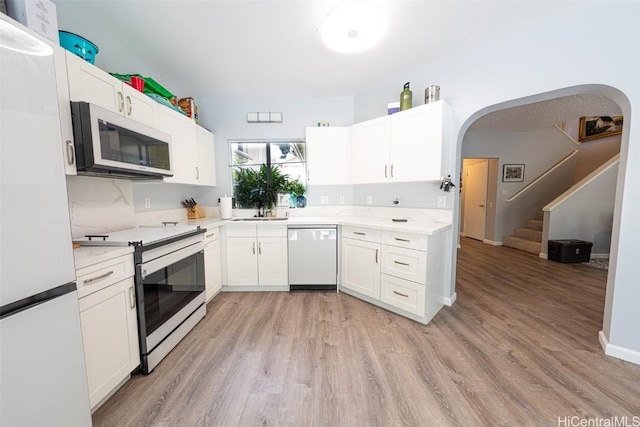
[78,278,140,408]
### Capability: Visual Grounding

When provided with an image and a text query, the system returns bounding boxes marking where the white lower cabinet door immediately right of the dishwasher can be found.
[341,239,380,299]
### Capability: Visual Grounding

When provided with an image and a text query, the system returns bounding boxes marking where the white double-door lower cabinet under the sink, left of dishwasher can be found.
[225,225,289,287]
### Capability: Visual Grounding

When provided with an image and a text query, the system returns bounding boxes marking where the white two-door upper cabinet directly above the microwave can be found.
[66,52,159,126]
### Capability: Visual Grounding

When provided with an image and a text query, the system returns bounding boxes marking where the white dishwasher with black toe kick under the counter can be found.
[288,225,338,291]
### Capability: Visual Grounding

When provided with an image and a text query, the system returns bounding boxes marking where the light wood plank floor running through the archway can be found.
[93,239,640,427]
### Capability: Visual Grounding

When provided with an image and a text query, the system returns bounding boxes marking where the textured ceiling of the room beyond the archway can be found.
[469,95,622,132]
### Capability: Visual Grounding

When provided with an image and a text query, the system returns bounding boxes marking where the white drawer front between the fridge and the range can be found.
[76,255,135,298]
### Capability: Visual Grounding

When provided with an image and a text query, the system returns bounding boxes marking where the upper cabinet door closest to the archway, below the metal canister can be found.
[389,101,444,182]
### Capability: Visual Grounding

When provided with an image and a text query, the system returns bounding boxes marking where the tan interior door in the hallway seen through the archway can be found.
[463,159,489,240]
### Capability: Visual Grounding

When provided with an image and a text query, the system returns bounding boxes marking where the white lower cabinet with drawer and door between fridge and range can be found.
[76,255,140,410]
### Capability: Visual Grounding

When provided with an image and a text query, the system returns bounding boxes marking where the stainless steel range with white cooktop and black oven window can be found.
[76,223,206,374]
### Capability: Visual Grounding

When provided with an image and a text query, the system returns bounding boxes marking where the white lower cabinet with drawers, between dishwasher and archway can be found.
[340,226,444,323]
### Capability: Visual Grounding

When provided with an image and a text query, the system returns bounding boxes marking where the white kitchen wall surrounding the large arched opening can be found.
[354,1,640,363]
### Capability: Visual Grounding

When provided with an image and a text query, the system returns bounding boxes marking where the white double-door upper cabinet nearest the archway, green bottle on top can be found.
[351,100,449,184]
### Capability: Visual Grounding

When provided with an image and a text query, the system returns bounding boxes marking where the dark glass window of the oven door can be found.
[142,252,204,336]
